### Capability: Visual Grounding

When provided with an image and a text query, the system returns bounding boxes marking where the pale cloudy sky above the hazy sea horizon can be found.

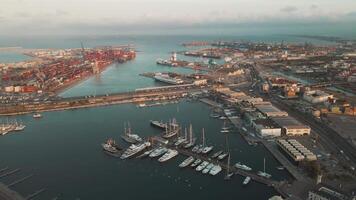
[0,0,356,35]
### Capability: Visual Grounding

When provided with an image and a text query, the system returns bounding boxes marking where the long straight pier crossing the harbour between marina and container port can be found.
[0,84,206,116]
